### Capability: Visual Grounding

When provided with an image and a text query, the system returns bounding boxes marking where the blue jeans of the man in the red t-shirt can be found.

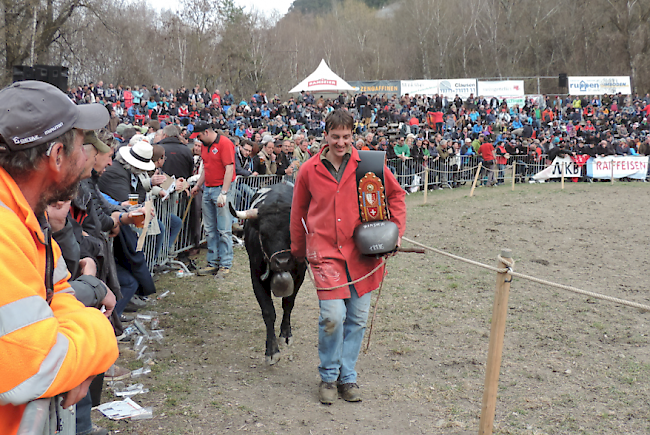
[203,186,235,269]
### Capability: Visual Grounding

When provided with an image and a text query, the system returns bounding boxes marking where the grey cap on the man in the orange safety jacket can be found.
[0,80,110,152]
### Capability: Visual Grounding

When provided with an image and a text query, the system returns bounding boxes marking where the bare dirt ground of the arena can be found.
[94,182,650,435]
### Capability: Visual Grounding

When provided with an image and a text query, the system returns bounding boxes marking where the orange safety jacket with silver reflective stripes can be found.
[0,168,118,435]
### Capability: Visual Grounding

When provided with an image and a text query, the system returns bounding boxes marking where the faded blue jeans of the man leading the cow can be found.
[318,285,370,384]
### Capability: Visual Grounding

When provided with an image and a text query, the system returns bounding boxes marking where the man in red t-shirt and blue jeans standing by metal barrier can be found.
[190,121,235,277]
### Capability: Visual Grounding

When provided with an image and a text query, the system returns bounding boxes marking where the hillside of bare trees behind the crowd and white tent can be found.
[0,0,650,96]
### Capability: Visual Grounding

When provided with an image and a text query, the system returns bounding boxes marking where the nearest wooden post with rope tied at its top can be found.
[478,249,512,435]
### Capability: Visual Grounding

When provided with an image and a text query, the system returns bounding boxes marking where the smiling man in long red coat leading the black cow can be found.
[291,110,406,405]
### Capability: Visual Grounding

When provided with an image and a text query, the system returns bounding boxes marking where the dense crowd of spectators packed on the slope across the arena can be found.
[68,81,650,195]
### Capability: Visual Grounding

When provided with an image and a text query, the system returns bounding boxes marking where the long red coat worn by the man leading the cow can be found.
[291,146,406,300]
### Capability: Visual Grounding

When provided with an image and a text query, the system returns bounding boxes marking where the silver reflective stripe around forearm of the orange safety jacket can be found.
[0,332,69,406]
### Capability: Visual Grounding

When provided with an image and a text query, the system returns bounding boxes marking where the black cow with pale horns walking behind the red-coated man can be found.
[230,183,306,365]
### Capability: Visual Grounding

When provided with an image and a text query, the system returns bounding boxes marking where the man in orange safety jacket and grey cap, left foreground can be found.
[0,81,118,434]
